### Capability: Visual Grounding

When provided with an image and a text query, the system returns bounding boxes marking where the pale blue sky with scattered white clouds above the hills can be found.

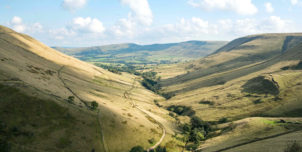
[0,0,302,47]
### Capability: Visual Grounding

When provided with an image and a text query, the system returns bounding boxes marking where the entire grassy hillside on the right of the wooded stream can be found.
[154,34,302,152]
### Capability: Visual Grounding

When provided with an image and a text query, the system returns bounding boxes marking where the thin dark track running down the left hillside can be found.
[58,66,110,152]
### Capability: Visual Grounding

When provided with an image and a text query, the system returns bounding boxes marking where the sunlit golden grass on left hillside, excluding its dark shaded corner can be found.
[0,26,179,152]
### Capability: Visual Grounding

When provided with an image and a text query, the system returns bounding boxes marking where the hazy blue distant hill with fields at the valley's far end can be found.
[53,41,227,64]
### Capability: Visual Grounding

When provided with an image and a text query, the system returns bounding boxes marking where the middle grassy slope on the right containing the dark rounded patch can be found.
[163,43,302,121]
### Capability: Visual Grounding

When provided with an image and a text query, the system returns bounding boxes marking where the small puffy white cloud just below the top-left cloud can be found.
[72,17,105,33]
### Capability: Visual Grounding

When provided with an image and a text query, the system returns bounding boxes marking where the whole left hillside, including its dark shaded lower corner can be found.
[0,26,174,152]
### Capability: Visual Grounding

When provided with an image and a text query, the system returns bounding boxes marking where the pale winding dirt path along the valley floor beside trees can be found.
[124,78,166,152]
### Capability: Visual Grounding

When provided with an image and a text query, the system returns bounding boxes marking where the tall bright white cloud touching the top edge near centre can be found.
[121,0,153,25]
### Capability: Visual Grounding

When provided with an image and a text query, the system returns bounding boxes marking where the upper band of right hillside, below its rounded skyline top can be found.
[157,33,302,82]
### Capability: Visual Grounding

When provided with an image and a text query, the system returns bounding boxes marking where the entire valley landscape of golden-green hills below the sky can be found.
[0,26,302,152]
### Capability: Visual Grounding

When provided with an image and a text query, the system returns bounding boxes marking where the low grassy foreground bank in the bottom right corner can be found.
[200,117,302,152]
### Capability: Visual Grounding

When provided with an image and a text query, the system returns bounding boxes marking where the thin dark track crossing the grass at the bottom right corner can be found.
[195,129,302,152]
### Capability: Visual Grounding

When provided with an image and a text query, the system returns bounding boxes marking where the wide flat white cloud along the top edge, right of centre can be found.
[188,0,258,15]
